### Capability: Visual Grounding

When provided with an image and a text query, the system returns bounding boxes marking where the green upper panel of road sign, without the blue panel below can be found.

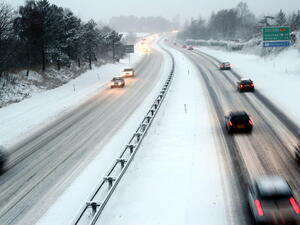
[262,27,291,41]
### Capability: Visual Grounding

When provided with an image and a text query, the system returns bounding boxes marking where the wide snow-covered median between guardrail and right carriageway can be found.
[97,44,226,225]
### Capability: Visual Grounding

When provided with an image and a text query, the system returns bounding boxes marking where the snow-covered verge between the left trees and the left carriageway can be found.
[0,42,143,149]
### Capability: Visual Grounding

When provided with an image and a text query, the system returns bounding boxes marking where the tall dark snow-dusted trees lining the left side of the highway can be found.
[0,0,122,75]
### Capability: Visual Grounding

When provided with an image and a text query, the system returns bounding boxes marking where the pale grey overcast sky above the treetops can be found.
[5,0,300,22]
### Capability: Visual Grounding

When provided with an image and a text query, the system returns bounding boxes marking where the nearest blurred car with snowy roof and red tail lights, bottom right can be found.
[248,176,300,224]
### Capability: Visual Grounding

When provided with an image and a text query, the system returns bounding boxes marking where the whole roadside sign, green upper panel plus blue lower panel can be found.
[262,26,291,47]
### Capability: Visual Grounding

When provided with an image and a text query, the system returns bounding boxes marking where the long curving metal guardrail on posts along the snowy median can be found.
[72,43,175,225]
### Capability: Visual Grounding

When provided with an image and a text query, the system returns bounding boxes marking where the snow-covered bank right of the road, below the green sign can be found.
[199,47,300,126]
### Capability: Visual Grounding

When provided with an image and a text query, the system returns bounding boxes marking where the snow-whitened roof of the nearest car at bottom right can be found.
[255,176,292,196]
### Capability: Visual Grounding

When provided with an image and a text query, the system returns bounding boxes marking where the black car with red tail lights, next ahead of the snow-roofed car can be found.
[225,111,253,134]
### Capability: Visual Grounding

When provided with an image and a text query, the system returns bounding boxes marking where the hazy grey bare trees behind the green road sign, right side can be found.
[178,2,300,40]
